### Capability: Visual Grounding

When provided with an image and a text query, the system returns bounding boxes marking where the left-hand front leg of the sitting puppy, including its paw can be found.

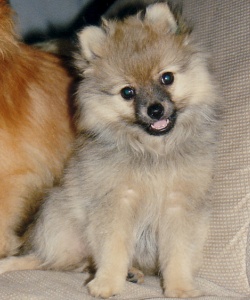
[88,191,137,298]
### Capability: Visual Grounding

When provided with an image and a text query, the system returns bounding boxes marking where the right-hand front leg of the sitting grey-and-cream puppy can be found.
[159,193,208,298]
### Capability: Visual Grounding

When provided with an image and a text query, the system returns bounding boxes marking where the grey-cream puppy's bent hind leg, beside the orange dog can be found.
[29,193,89,270]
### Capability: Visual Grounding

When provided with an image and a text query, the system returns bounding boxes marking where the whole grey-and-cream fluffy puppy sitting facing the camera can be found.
[0,3,218,298]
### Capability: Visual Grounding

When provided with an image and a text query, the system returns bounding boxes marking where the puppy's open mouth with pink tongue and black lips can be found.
[146,111,177,135]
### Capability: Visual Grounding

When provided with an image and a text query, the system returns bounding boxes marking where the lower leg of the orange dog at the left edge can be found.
[0,172,43,258]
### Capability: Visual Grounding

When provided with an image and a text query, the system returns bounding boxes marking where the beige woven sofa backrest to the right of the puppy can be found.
[180,0,250,295]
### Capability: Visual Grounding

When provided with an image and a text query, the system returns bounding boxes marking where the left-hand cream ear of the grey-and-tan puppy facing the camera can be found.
[78,26,106,61]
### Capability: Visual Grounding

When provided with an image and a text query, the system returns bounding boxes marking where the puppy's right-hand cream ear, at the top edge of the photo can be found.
[145,3,178,33]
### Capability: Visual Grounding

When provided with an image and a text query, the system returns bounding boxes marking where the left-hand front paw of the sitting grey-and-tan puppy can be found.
[87,277,123,298]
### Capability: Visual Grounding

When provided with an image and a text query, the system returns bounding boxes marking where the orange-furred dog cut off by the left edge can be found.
[0,1,73,257]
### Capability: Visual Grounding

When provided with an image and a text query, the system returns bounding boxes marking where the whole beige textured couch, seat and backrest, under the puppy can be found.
[0,0,250,300]
